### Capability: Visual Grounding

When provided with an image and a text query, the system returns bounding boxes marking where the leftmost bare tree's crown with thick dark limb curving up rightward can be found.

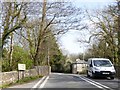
[1,2,26,48]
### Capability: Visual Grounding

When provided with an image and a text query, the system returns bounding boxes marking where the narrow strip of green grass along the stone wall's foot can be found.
[0,75,43,88]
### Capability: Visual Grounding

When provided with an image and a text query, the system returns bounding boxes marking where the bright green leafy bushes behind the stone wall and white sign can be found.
[2,46,33,71]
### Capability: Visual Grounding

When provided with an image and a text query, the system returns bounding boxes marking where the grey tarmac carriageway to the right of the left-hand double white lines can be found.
[40,73,119,90]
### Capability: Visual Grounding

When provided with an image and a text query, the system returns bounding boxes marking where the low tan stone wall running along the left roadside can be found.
[0,66,51,85]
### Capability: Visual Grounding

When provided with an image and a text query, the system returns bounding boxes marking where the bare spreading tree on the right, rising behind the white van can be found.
[82,6,119,63]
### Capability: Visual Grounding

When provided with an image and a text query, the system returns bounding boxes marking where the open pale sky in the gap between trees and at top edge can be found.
[60,0,115,54]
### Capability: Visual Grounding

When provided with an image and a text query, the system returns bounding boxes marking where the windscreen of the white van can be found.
[93,60,112,67]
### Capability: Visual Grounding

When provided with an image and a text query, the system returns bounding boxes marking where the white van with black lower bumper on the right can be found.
[87,58,116,79]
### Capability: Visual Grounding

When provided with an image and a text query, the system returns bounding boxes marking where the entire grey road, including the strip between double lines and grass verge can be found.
[2,73,120,90]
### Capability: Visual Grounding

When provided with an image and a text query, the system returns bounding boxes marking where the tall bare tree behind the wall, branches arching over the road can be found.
[13,0,85,65]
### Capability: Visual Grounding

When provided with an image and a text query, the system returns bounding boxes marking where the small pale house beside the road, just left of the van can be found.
[72,59,87,74]
